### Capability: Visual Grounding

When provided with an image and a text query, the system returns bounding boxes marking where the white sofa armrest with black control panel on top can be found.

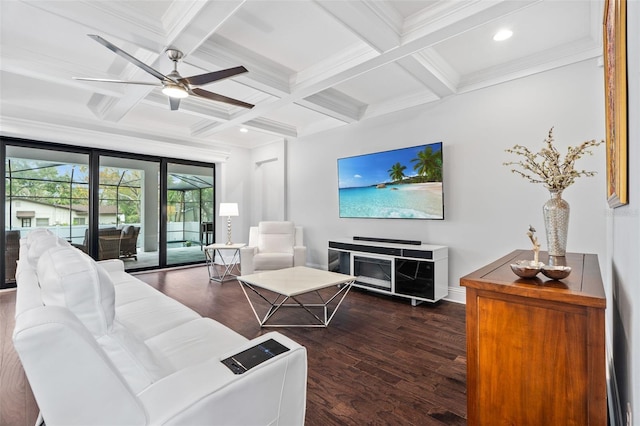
[139,332,307,425]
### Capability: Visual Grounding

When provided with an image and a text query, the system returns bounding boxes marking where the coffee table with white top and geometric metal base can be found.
[237,266,356,327]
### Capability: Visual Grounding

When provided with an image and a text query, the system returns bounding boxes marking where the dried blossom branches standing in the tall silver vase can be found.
[503,127,604,190]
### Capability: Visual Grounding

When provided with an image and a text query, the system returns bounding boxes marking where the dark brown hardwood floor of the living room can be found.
[0,267,467,426]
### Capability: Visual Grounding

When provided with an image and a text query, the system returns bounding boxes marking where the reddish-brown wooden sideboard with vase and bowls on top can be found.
[460,250,607,426]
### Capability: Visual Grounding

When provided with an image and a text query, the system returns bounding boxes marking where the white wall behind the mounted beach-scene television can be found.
[287,60,608,301]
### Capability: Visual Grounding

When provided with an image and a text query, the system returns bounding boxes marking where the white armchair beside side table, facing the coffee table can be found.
[240,222,307,275]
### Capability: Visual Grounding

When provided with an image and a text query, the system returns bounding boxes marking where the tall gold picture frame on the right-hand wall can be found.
[602,0,628,208]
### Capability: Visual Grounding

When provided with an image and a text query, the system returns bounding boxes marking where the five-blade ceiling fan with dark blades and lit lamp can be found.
[73,34,253,111]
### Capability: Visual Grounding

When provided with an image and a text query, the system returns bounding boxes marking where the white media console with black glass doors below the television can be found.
[328,237,449,306]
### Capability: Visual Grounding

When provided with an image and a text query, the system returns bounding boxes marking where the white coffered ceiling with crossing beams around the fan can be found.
[0,0,602,158]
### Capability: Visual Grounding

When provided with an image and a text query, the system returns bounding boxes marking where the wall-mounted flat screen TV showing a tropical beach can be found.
[338,142,444,219]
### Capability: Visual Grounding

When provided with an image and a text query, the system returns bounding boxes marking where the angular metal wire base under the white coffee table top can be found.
[238,280,353,327]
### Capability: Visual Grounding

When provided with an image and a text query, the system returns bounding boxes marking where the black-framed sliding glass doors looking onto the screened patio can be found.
[3,144,214,284]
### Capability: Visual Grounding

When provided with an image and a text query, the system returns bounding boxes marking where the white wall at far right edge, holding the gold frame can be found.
[607,1,640,425]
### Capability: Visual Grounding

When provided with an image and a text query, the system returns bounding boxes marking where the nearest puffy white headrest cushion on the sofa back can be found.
[37,245,115,337]
